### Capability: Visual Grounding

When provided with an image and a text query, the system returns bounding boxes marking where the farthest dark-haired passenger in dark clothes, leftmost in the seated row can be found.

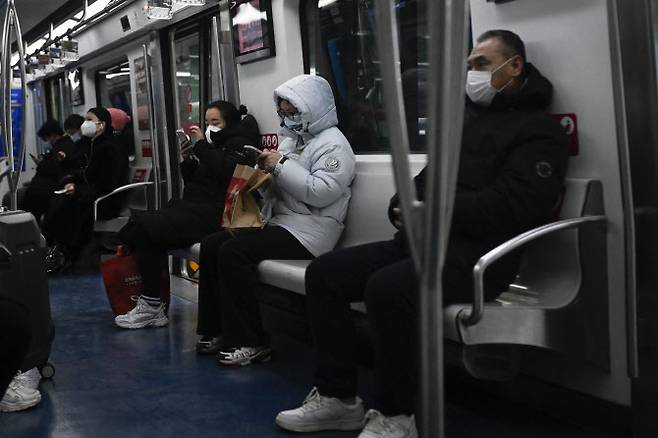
[19,120,75,223]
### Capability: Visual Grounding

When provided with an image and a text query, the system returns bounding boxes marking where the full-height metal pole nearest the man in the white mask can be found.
[419,0,469,437]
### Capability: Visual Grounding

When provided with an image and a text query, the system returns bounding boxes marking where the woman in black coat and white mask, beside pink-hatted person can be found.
[43,107,127,271]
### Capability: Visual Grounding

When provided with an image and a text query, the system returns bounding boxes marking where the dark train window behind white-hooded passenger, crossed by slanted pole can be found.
[301,0,428,153]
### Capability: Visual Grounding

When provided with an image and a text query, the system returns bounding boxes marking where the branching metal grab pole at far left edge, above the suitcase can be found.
[0,0,27,210]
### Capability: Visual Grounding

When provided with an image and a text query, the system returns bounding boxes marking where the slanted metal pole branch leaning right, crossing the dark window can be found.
[375,0,423,274]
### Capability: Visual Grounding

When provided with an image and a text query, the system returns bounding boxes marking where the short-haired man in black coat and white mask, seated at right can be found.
[276,31,568,438]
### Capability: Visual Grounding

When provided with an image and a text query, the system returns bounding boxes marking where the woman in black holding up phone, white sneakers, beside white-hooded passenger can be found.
[115,101,260,328]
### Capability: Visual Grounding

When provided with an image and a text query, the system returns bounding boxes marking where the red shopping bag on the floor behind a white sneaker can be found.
[101,246,170,315]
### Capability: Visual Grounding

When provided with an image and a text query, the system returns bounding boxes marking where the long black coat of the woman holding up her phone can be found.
[125,115,260,249]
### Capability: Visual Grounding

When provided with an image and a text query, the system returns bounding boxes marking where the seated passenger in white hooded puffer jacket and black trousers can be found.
[192,75,355,365]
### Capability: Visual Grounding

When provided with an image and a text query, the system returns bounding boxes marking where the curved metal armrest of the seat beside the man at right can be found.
[460,215,607,327]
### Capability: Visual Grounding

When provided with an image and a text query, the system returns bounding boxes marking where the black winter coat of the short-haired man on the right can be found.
[389,64,569,298]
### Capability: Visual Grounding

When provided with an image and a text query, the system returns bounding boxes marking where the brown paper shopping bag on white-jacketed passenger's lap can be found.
[222,164,271,230]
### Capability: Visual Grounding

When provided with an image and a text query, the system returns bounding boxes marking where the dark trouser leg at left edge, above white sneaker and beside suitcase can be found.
[0,297,32,398]
